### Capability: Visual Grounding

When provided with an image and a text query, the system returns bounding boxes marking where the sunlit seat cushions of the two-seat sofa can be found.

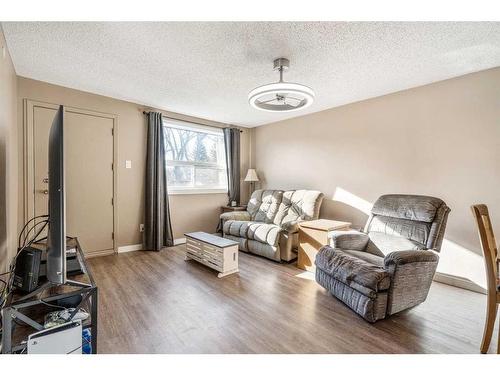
[223,220,281,246]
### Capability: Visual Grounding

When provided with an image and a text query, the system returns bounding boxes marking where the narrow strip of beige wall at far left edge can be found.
[0,26,18,272]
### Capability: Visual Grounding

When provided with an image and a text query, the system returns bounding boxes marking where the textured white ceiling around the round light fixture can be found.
[2,22,500,127]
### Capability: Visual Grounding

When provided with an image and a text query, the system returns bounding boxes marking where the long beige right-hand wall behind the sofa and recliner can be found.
[255,68,500,286]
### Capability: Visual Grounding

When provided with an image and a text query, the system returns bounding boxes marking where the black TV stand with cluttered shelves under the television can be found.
[2,238,97,354]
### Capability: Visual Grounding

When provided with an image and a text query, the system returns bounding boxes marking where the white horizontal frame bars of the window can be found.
[163,118,228,195]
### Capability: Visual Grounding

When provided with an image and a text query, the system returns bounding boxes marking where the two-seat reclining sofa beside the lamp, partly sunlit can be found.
[220,190,323,262]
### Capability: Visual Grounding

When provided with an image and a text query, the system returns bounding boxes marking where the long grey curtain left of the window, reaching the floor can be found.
[143,112,174,251]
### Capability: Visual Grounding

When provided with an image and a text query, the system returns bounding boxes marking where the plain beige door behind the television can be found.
[26,101,115,255]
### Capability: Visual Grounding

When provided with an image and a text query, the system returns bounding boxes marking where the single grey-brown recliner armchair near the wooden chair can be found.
[316,195,450,322]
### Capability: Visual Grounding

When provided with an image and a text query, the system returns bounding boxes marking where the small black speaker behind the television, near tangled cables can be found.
[13,247,42,293]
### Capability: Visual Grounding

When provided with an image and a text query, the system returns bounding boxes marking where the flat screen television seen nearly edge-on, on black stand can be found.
[46,106,66,284]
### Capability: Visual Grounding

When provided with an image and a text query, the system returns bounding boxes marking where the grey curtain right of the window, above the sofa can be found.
[224,128,240,204]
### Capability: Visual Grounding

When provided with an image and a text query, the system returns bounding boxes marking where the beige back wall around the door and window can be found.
[18,77,251,250]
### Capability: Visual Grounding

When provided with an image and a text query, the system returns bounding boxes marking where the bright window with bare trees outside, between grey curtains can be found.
[163,119,227,194]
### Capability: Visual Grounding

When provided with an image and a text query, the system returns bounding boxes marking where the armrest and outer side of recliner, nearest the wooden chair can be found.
[384,250,439,315]
